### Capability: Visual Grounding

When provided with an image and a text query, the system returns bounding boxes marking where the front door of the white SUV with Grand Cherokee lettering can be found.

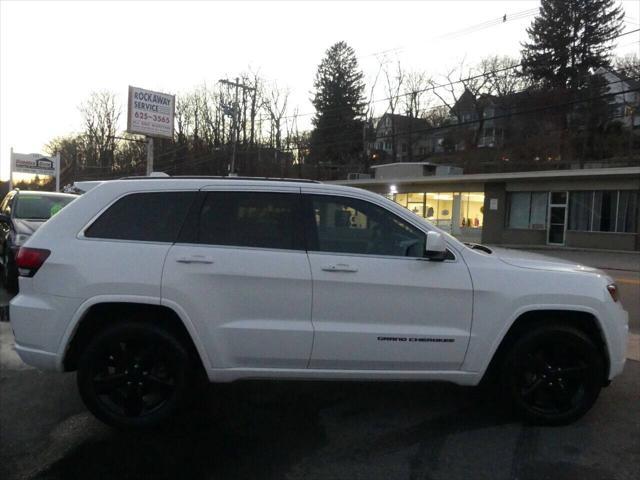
[303,189,472,371]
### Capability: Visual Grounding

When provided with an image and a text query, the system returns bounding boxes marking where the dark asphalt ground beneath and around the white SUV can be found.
[0,252,640,480]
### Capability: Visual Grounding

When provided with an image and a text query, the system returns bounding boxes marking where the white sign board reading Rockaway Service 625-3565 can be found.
[127,86,176,138]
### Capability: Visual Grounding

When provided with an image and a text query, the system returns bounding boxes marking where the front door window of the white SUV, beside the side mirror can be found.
[307,195,425,257]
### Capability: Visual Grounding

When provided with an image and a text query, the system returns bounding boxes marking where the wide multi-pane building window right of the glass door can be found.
[568,190,638,233]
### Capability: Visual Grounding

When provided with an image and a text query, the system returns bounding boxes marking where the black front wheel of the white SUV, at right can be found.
[501,324,604,425]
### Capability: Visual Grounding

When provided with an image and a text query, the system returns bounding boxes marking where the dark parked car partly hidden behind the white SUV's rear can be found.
[0,189,76,292]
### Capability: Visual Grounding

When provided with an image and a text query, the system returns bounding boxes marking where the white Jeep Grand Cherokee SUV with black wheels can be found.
[10,178,628,427]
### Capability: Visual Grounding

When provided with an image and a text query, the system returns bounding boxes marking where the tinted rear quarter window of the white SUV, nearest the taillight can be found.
[84,192,196,242]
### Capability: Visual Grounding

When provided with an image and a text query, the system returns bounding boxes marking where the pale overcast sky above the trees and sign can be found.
[0,0,640,179]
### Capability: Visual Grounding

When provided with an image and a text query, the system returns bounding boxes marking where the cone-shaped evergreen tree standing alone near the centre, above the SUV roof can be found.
[310,42,365,164]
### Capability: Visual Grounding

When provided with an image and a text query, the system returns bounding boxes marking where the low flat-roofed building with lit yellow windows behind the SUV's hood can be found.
[334,162,640,251]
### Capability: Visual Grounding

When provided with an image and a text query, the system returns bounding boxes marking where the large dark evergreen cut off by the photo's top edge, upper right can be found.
[522,0,624,89]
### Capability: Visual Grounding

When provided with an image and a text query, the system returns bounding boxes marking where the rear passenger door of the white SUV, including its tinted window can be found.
[162,185,313,369]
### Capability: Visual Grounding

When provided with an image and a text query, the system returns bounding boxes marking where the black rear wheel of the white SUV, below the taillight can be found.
[77,321,194,429]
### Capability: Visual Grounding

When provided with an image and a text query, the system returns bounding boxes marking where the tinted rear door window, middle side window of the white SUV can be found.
[198,192,304,250]
